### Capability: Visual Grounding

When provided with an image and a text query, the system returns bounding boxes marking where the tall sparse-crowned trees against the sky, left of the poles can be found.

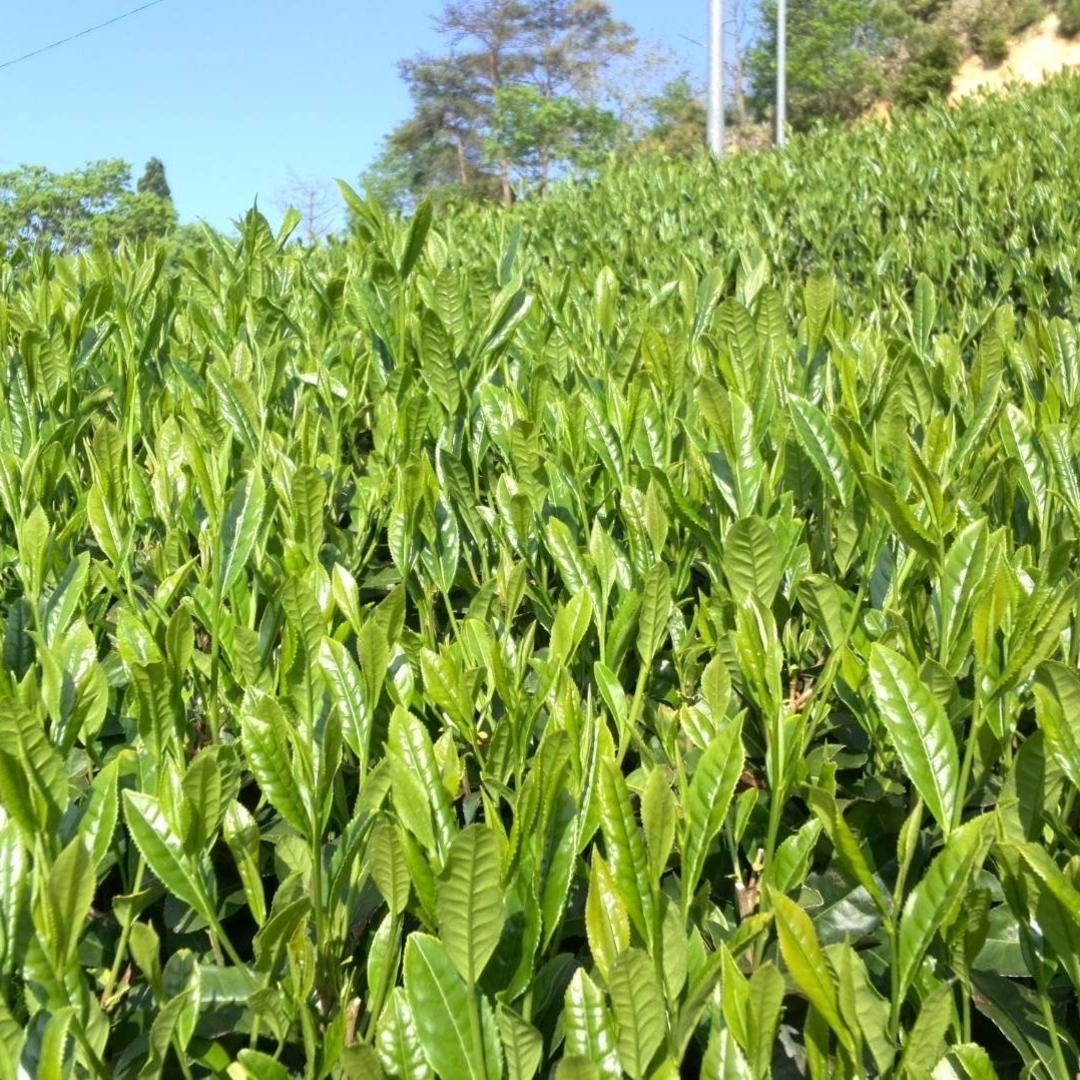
[361,0,633,206]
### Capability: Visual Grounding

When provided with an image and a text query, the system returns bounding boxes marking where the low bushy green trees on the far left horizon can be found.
[0,160,176,255]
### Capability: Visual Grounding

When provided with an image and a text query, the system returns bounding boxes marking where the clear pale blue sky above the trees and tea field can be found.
[0,0,725,228]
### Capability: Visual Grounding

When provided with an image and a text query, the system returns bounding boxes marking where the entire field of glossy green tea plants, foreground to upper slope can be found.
[0,77,1080,1080]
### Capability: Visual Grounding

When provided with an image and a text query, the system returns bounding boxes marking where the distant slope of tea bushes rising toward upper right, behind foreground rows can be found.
[483,76,1080,339]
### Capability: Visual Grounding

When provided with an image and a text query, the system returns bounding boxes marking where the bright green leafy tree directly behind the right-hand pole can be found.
[748,0,888,130]
